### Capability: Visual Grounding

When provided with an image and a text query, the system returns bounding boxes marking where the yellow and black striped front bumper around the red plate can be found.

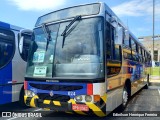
[24,95,106,117]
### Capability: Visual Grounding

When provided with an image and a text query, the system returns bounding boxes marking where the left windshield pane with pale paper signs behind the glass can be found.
[27,24,59,77]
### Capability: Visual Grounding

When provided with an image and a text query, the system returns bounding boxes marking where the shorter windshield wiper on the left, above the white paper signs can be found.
[42,24,51,51]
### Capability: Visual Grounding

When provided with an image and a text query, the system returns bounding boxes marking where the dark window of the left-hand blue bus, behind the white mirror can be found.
[20,34,31,61]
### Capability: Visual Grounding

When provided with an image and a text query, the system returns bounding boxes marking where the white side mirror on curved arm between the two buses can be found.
[18,29,33,54]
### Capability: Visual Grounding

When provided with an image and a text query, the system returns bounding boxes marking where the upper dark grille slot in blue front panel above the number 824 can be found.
[29,83,83,91]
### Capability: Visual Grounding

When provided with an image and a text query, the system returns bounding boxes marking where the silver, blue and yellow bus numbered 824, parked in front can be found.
[24,2,151,116]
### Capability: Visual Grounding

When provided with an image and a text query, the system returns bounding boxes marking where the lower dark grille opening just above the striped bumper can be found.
[37,93,70,102]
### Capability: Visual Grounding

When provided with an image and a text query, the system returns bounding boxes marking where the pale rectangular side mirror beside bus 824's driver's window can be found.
[115,27,123,45]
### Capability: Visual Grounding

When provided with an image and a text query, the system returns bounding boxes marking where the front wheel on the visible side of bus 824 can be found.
[120,86,129,111]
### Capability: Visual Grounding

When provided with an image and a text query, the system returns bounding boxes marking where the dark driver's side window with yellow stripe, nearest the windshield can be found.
[106,24,121,77]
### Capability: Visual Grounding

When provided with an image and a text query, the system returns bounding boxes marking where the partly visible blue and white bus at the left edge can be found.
[0,21,32,105]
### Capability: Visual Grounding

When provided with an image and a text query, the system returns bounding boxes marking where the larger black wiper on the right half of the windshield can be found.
[61,15,81,48]
